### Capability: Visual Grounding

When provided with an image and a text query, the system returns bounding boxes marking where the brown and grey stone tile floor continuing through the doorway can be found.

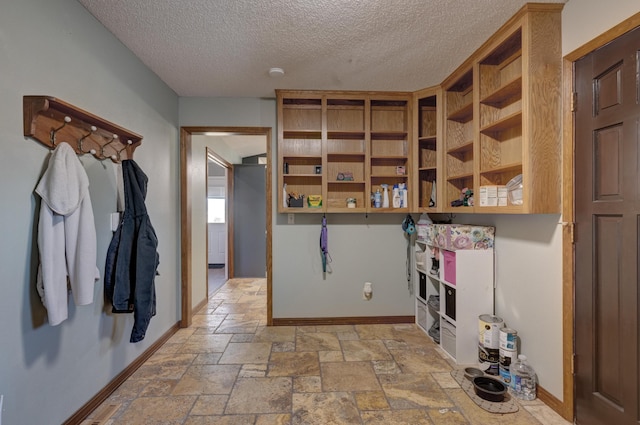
[84,279,568,425]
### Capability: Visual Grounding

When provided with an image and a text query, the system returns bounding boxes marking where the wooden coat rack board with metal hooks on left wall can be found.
[23,96,142,162]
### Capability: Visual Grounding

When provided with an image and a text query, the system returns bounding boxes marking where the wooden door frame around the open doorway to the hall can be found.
[180,126,273,328]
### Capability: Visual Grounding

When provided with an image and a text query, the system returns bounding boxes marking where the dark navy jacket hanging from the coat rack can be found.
[104,159,159,342]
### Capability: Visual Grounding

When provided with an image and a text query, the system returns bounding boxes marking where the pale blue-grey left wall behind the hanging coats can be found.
[0,0,180,425]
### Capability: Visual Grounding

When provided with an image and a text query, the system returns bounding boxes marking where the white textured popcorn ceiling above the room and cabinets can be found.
[79,0,565,97]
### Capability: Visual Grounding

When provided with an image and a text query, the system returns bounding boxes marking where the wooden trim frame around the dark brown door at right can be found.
[564,9,640,421]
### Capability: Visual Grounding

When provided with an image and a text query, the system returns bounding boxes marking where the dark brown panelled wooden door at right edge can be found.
[575,29,640,425]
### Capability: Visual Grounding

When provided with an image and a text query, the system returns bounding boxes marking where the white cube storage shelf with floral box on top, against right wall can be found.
[415,224,495,364]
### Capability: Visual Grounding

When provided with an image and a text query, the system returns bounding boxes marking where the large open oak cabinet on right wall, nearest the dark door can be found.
[443,4,562,214]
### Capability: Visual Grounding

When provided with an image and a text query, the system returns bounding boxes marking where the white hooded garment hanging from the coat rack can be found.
[36,143,100,326]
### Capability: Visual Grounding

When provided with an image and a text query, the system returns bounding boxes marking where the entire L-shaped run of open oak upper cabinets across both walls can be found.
[276,3,563,214]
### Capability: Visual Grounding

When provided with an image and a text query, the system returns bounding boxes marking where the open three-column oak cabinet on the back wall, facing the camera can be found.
[276,90,412,213]
